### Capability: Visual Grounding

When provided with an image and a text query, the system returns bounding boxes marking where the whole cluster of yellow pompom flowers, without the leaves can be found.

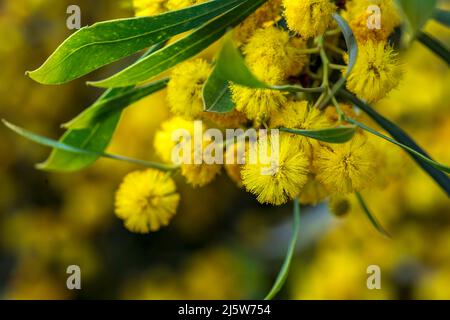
[116,0,402,232]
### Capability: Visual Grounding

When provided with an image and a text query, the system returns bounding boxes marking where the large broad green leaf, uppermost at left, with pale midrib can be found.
[29,0,241,84]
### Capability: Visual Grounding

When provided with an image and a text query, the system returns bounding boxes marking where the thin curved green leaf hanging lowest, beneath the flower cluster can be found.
[265,199,300,300]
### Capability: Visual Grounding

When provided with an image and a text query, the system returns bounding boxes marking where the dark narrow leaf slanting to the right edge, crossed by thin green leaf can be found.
[339,89,450,196]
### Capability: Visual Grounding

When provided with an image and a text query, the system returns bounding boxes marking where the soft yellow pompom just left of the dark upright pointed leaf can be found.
[167,59,211,119]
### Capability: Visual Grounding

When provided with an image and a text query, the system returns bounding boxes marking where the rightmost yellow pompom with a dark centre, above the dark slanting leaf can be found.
[347,40,402,102]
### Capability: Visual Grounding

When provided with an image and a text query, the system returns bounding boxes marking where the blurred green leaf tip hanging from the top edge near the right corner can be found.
[397,0,438,36]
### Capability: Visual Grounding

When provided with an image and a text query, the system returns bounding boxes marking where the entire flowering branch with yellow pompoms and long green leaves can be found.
[4,0,450,298]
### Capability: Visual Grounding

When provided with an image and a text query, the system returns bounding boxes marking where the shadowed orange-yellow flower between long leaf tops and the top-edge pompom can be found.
[233,0,281,44]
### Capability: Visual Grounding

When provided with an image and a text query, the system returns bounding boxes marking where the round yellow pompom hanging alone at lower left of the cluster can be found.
[115,169,180,233]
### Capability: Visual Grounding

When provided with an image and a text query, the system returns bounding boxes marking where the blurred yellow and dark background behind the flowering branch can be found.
[0,0,450,299]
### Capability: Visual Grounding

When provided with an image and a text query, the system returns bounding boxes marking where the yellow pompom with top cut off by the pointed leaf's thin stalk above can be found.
[230,84,287,120]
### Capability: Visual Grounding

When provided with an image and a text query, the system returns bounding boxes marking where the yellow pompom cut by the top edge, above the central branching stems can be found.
[283,0,336,39]
